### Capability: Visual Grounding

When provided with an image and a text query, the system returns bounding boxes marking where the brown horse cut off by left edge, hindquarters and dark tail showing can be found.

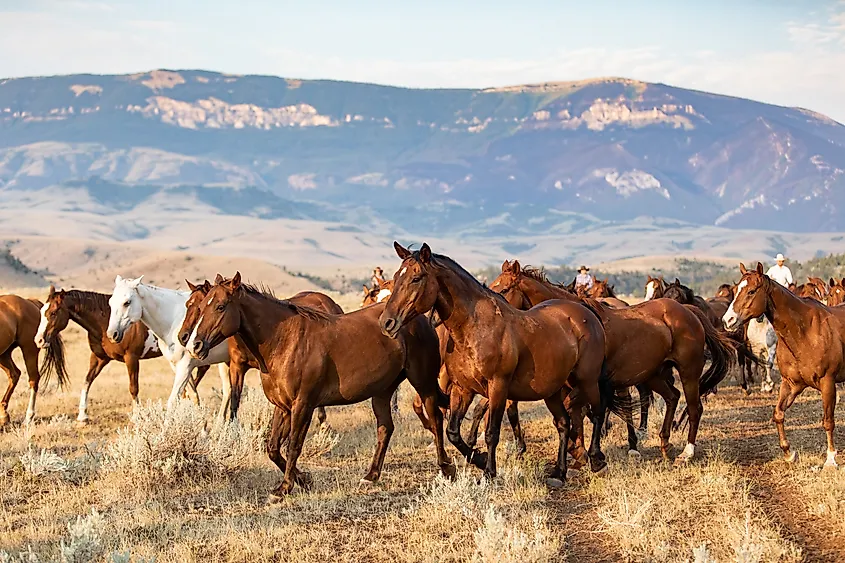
[0,295,67,426]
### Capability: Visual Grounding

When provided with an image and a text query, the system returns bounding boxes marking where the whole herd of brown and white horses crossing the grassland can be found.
[0,243,845,497]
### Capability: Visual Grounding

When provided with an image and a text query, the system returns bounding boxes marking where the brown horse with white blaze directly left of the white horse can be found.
[35,285,166,424]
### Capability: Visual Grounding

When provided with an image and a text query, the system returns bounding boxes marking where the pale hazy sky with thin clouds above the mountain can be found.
[0,0,845,122]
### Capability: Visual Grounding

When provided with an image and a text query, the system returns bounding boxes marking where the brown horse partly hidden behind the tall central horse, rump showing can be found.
[484,261,733,462]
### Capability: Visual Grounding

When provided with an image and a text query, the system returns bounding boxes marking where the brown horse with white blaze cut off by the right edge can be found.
[725,262,845,468]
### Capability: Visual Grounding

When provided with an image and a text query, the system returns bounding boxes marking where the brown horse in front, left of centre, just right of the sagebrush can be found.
[180,273,455,496]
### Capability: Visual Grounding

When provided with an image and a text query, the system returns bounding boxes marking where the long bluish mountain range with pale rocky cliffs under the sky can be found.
[0,70,845,270]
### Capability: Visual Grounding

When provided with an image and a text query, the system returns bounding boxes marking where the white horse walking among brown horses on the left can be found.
[108,276,232,419]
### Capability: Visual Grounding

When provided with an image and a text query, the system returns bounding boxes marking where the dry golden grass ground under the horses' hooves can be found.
[0,298,845,563]
